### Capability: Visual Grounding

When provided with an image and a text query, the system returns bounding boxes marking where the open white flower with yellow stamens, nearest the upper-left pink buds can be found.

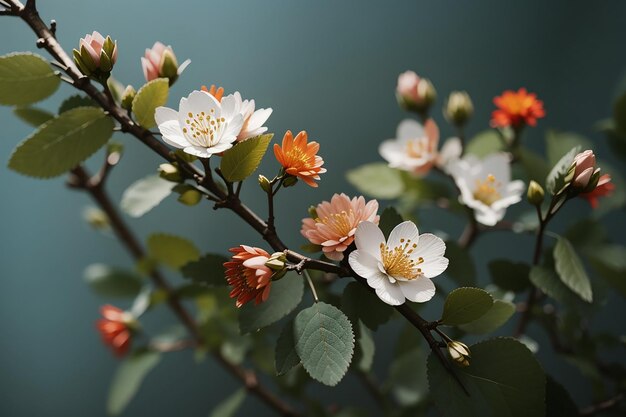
[154,91,243,158]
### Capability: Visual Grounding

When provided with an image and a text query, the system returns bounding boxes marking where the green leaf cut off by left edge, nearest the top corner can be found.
[0,52,61,106]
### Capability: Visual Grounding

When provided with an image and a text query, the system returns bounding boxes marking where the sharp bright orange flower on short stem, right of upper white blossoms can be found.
[274,130,326,187]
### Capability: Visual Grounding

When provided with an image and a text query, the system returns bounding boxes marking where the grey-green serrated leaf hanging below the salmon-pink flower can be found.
[294,302,354,386]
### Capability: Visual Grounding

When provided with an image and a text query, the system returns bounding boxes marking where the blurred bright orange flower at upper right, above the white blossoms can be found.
[491,88,546,127]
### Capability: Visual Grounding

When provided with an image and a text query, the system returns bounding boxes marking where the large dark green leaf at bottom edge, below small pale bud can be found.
[428,338,546,417]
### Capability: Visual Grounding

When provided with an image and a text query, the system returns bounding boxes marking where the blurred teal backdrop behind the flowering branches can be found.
[0,0,626,417]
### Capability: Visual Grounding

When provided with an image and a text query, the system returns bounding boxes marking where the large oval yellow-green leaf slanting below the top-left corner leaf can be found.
[9,107,114,178]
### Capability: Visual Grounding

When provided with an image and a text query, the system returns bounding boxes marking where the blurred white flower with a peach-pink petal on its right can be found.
[378,119,439,175]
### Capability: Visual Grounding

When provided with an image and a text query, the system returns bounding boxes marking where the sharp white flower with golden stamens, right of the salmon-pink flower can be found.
[348,221,448,305]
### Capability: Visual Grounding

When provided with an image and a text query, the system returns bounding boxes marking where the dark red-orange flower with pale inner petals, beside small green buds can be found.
[224,245,273,307]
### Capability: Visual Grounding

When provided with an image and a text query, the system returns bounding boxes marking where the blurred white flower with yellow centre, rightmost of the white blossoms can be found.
[449,153,524,226]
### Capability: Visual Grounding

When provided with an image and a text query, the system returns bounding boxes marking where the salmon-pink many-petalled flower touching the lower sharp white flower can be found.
[300,193,379,261]
